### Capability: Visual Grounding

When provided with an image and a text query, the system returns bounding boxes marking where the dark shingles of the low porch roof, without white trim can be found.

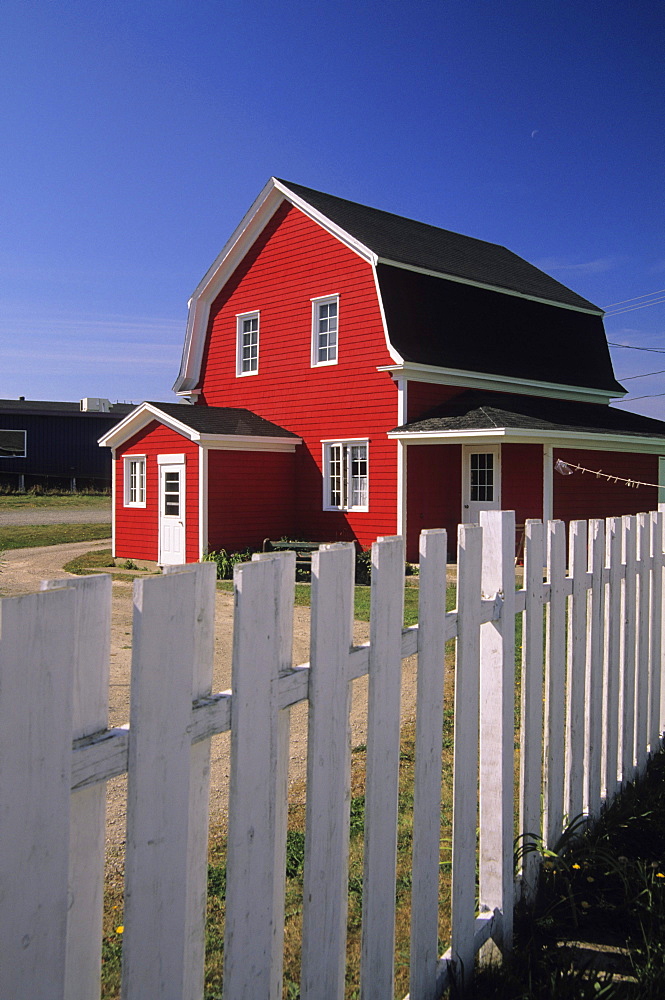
[396,390,665,438]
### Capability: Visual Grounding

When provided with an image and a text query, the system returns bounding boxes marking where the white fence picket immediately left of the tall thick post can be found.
[450,524,483,979]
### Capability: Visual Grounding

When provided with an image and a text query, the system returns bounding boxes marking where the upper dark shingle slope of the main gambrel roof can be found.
[280,180,601,312]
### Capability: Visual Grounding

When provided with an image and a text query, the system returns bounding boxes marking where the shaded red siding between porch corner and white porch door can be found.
[406,444,462,562]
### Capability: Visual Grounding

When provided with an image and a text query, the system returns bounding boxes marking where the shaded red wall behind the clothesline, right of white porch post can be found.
[554,448,658,521]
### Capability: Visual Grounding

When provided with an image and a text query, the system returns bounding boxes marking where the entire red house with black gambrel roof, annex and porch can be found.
[100,178,665,563]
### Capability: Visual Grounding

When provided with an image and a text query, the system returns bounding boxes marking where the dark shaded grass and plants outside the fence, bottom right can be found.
[462,752,665,1000]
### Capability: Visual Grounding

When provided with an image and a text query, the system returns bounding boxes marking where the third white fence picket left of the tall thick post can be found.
[360,538,404,1000]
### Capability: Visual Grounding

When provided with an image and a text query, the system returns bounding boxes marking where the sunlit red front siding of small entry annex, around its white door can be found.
[115,420,199,562]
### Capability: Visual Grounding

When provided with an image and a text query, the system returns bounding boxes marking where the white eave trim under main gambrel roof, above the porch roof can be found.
[377,361,626,403]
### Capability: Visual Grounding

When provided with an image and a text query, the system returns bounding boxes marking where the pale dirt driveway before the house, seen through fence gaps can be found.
[0,540,416,853]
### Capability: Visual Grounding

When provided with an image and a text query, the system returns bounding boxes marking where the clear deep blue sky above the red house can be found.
[0,0,665,419]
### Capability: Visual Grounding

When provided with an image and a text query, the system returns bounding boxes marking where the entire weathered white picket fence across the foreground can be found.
[0,512,665,1000]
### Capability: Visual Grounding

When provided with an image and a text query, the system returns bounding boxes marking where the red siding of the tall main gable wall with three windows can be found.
[195,206,397,546]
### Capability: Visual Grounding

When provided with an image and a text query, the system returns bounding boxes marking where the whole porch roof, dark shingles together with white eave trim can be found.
[389,390,665,450]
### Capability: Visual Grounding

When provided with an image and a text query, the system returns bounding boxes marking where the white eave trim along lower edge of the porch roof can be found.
[388,427,665,455]
